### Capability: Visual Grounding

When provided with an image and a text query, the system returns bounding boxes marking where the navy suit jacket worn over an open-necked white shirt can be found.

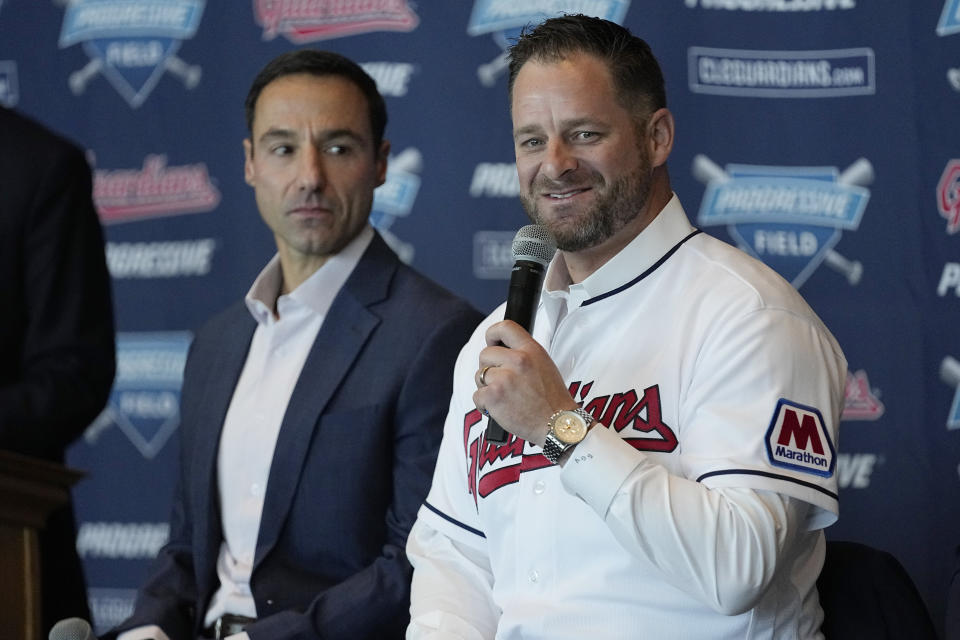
[113,235,481,640]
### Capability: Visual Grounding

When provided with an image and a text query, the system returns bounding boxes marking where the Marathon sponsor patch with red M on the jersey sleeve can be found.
[766,398,836,477]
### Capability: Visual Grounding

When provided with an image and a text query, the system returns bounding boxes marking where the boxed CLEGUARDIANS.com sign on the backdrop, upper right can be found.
[687,47,877,98]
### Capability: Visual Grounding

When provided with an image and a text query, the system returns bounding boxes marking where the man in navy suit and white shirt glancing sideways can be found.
[111,50,480,640]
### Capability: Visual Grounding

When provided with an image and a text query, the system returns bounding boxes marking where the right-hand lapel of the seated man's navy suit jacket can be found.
[254,235,398,566]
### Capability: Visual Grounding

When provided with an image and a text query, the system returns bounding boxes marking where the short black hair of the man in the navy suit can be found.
[244,49,387,149]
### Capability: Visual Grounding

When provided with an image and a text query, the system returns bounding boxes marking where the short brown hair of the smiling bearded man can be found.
[507,14,667,115]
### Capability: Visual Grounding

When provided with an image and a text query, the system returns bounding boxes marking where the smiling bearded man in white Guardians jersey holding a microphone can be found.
[407,16,846,640]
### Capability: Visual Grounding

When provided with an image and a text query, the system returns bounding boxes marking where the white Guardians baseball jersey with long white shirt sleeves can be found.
[407,197,846,640]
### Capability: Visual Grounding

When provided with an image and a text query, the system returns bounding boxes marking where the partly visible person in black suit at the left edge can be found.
[0,107,115,635]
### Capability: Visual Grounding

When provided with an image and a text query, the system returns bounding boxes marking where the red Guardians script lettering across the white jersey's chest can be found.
[463,381,678,502]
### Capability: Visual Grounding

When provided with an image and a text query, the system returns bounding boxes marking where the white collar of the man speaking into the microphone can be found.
[544,194,694,308]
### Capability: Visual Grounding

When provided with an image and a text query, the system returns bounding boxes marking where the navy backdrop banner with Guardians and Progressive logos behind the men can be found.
[0,0,960,630]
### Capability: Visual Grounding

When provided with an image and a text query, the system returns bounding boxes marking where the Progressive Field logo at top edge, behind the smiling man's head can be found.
[467,0,630,87]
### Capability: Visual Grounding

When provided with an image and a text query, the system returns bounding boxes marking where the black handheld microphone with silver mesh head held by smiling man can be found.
[484,224,557,444]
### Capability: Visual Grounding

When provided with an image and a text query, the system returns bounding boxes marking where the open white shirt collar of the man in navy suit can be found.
[244,225,374,324]
